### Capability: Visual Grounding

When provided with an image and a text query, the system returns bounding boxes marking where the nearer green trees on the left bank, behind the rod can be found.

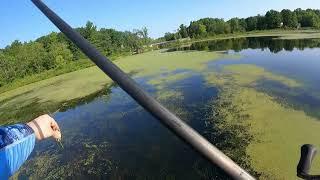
[0,22,151,87]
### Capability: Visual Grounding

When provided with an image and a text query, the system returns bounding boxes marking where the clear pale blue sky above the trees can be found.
[0,0,320,48]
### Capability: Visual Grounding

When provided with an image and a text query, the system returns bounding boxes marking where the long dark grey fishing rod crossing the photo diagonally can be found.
[31,0,255,179]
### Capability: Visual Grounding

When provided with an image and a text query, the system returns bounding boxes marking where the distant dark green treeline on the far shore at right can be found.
[161,8,320,41]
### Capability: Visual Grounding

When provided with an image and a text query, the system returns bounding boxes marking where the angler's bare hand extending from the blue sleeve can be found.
[27,114,61,140]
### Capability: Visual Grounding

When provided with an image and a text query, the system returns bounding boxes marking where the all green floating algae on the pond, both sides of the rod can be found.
[0,46,320,179]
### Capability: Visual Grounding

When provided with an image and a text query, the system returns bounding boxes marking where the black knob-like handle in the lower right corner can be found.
[297,144,320,180]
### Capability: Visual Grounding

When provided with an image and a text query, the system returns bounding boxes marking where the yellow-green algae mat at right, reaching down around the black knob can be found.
[207,64,320,179]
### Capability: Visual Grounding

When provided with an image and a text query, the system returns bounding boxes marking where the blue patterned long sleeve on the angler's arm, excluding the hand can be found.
[0,124,35,179]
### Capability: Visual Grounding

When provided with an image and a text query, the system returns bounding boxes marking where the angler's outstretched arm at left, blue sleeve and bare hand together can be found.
[0,114,61,180]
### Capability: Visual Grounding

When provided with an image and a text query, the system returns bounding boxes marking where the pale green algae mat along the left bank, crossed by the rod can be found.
[0,51,223,124]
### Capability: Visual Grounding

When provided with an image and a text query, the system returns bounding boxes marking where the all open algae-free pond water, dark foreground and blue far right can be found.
[19,37,320,179]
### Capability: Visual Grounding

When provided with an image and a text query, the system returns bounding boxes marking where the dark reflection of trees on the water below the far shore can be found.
[175,37,320,53]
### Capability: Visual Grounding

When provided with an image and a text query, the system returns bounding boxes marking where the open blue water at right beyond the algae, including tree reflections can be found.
[168,37,320,118]
